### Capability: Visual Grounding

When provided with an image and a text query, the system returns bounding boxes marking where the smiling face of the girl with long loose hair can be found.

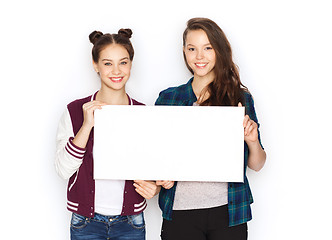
[183,29,216,81]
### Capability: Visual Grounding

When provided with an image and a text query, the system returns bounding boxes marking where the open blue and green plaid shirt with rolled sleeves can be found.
[155,78,261,227]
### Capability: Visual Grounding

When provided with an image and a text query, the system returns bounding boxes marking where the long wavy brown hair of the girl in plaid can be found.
[183,18,248,106]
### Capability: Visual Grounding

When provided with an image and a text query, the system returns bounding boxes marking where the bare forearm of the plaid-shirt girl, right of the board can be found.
[247,140,266,172]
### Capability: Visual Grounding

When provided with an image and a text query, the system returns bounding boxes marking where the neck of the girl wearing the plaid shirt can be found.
[192,74,214,103]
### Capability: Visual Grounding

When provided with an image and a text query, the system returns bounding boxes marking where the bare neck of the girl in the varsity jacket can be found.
[96,87,129,105]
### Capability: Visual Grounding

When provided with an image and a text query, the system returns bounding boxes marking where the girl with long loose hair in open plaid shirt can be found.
[156,18,266,240]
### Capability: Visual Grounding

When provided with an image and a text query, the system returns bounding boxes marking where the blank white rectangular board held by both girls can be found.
[93,105,244,182]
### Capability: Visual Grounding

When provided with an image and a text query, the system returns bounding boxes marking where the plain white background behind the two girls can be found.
[0,0,332,240]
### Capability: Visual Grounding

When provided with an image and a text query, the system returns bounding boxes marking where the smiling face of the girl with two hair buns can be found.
[93,44,132,90]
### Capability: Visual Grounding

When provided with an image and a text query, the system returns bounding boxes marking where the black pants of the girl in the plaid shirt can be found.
[161,205,248,240]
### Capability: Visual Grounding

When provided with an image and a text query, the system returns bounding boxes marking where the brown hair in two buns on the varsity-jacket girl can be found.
[89,28,134,63]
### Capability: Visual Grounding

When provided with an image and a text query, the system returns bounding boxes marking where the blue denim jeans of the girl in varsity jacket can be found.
[70,213,145,240]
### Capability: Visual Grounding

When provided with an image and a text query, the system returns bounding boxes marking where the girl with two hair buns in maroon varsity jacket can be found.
[55,29,160,240]
